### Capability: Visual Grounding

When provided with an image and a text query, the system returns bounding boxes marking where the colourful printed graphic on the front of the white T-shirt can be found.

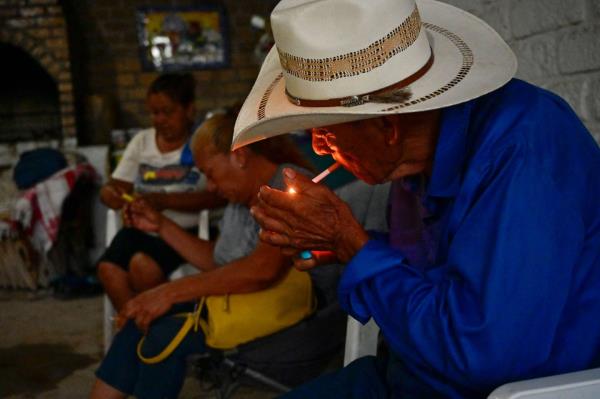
[135,164,200,193]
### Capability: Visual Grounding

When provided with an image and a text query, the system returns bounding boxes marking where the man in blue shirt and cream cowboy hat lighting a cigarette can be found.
[233,0,600,398]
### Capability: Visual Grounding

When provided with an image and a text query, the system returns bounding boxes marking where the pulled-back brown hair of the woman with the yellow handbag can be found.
[192,105,314,172]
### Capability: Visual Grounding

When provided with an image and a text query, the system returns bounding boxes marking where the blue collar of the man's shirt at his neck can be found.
[427,101,473,197]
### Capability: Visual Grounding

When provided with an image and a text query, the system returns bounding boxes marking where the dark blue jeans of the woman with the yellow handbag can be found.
[96,306,206,399]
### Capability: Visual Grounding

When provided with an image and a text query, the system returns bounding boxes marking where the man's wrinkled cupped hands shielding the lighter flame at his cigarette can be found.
[251,169,368,268]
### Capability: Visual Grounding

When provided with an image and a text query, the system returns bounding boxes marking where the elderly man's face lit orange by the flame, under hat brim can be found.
[312,119,394,184]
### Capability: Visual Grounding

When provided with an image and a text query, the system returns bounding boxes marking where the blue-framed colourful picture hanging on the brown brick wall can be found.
[137,5,229,72]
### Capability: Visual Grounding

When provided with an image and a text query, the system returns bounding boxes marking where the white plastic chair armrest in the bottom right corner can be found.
[488,368,600,399]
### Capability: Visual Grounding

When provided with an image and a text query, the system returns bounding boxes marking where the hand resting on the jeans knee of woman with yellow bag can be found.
[118,283,173,333]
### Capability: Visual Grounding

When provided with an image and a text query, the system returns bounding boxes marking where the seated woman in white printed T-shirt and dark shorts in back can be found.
[97,73,225,311]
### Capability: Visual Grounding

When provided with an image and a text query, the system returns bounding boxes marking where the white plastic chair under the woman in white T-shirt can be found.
[104,209,209,352]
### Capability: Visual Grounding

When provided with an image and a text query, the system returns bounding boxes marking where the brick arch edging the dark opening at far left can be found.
[0,0,76,146]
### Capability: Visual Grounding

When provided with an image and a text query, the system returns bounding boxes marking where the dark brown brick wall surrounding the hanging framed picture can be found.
[64,0,277,143]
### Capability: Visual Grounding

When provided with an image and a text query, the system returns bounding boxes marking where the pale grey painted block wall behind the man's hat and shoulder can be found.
[445,0,600,142]
